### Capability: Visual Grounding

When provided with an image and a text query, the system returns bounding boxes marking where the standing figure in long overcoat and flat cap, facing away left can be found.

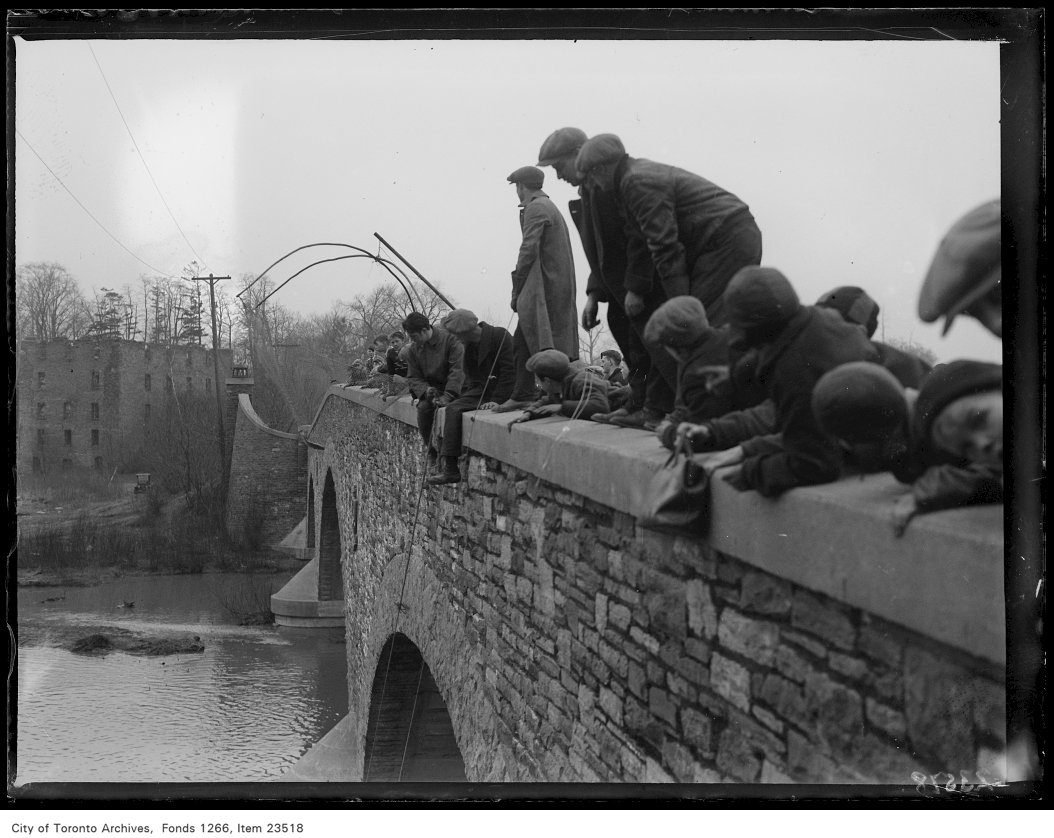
[495,165,579,412]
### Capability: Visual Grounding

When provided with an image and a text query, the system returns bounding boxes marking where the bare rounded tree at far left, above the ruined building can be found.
[15,261,89,340]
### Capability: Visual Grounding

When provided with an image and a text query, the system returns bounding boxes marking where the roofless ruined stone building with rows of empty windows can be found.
[16,338,232,473]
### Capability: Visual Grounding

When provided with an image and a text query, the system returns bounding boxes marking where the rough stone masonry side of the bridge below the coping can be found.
[301,395,1006,784]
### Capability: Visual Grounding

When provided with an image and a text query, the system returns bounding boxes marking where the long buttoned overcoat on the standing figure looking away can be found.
[512,191,579,360]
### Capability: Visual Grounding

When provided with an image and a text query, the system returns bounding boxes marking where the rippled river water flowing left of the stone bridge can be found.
[15,572,348,786]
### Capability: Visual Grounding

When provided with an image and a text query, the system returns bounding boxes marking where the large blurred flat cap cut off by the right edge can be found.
[918,200,1002,334]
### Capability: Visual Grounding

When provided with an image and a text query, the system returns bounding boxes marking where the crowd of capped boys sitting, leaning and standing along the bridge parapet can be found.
[337,128,1002,534]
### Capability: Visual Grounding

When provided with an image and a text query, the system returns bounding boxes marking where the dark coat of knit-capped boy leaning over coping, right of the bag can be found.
[741,306,878,495]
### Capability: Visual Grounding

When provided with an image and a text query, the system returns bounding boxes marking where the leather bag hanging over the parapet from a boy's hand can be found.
[641,441,710,534]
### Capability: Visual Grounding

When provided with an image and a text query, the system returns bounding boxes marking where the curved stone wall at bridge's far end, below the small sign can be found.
[227,395,308,546]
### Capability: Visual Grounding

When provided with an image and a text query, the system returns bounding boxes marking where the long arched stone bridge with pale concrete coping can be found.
[232,387,1007,785]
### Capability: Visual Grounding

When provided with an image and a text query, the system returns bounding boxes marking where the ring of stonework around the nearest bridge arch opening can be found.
[348,553,531,782]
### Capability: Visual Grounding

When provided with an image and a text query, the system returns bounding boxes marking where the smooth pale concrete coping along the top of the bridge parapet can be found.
[312,387,1007,665]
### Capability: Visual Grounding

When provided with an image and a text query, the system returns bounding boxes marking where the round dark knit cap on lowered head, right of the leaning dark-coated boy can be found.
[813,360,907,442]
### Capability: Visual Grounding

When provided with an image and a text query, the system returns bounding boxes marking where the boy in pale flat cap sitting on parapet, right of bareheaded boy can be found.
[428,309,516,484]
